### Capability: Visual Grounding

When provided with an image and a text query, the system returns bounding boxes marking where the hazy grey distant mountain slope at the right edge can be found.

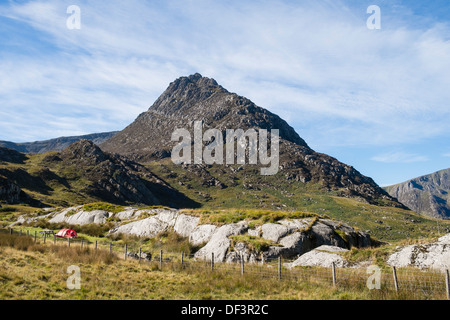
[385,169,450,219]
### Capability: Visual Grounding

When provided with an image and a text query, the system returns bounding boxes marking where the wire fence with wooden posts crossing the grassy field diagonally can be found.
[0,229,450,300]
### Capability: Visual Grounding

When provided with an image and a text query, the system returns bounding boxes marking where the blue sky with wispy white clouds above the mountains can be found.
[0,0,450,185]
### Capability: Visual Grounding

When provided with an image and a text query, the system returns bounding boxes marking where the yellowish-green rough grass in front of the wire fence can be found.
[0,233,443,300]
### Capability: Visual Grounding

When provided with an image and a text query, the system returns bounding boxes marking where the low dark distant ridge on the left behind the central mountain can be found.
[0,131,117,153]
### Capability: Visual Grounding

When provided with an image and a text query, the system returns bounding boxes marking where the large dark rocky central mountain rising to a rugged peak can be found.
[100,73,402,207]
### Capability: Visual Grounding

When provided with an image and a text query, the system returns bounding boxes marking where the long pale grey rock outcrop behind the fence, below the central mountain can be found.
[17,206,371,262]
